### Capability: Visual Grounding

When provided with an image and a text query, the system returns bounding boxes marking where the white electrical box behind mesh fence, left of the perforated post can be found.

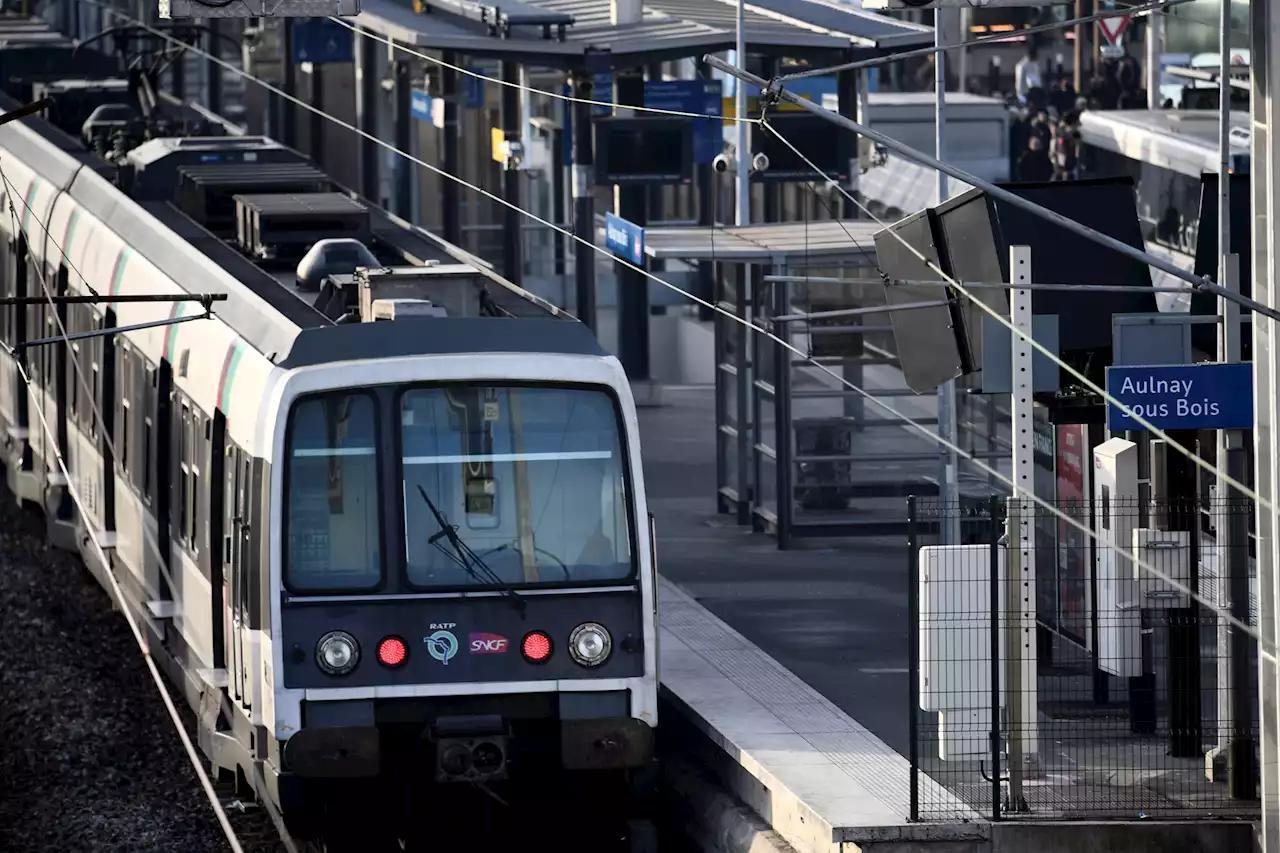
[919,544,1037,761]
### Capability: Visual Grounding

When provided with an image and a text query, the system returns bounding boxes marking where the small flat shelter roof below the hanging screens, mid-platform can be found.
[644,219,883,266]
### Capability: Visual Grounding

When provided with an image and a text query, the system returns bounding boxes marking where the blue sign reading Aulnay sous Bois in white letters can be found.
[1107,362,1253,430]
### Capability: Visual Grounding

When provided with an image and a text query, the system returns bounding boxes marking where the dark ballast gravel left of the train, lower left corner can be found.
[0,485,284,853]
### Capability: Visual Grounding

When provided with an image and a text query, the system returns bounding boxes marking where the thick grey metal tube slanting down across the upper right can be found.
[703,54,1280,320]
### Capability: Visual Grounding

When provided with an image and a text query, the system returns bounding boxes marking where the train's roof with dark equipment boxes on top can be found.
[0,17,576,364]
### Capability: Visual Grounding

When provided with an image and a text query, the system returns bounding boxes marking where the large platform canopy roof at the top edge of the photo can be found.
[353,0,933,70]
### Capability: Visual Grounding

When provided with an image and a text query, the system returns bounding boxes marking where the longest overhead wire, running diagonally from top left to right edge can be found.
[72,0,1276,660]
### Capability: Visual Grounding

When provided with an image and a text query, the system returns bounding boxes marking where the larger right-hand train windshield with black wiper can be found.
[398,384,634,588]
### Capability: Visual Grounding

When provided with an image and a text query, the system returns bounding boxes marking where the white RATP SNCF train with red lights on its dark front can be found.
[0,17,658,852]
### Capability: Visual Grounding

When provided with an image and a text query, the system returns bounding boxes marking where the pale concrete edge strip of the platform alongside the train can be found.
[659,571,979,853]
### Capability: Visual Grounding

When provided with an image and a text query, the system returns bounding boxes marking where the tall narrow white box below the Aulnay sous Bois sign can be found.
[1093,438,1142,678]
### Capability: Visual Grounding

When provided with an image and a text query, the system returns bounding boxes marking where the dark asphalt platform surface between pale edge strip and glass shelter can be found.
[639,388,918,754]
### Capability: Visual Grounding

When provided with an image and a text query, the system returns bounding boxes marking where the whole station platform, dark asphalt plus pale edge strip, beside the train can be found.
[639,378,1252,853]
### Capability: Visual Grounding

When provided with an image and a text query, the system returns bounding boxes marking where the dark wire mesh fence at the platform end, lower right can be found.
[908,498,1258,821]
